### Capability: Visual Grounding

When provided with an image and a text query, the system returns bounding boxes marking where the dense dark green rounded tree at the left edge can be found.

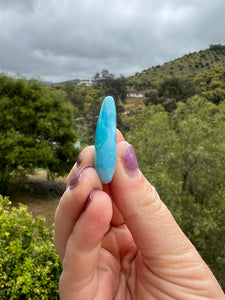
[0,75,77,194]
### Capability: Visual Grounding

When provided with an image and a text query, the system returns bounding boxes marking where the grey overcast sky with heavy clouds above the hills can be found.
[0,0,225,82]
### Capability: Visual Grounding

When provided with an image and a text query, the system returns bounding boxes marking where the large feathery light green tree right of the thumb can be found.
[127,97,225,288]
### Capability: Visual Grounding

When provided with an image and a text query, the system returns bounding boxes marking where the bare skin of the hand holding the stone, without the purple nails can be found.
[55,131,225,300]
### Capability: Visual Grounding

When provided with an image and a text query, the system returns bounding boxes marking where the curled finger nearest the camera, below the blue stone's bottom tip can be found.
[59,190,112,299]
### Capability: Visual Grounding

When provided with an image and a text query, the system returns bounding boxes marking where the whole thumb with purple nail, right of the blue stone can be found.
[110,142,224,299]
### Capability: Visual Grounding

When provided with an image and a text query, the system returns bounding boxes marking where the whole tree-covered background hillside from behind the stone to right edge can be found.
[46,45,225,146]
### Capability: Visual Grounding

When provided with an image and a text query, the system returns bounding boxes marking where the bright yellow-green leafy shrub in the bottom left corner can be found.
[0,195,61,300]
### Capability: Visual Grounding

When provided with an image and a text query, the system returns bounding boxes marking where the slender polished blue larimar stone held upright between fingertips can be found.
[95,96,116,183]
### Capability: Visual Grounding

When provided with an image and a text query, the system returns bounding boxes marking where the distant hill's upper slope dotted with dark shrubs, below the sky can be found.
[127,44,225,90]
